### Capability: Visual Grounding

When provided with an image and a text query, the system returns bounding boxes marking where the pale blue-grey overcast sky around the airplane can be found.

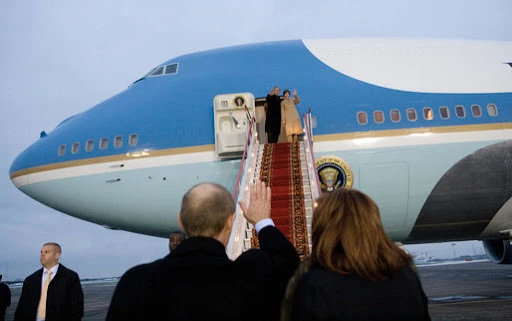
[0,0,512,280]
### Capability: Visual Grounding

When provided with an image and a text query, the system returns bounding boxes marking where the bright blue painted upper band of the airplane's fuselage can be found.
[10,40,512,174]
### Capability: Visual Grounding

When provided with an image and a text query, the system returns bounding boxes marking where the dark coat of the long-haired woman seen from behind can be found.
[291,266,430,321]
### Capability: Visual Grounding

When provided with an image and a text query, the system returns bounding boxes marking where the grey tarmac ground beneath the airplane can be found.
[6,261,512,321]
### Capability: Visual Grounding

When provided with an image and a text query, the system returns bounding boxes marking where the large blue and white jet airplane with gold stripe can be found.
[10,38,512,264]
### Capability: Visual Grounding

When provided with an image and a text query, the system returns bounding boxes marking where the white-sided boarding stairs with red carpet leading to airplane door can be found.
[226,113,320,260]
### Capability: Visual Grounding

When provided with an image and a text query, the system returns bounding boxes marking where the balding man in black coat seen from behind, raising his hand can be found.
[107,182,299,321]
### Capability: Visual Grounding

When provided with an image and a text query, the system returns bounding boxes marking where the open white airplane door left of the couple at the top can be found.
[213,93,255,158]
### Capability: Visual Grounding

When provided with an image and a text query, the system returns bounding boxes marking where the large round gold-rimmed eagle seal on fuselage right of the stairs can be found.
[315,156,354,192]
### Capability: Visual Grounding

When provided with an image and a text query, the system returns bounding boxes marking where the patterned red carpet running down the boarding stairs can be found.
[251,142,309,259]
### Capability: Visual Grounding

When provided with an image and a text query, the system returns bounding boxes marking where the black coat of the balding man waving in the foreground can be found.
[107,226,299,321]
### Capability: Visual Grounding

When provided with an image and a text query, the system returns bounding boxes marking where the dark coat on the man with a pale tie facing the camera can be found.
[14,264,84,321]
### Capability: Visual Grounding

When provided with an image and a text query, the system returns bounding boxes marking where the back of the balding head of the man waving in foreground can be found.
[180,183,235,237]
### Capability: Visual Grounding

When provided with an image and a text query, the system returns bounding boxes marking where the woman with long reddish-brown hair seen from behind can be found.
[282,188,430,321]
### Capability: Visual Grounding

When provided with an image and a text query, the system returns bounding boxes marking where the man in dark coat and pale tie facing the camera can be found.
[14,242,84,321]
